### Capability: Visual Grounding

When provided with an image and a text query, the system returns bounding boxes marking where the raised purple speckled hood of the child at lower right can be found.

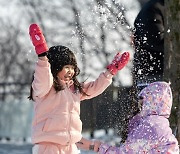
[139,82,172,118]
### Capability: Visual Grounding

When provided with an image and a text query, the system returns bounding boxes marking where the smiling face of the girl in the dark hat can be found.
[57,65,75,82]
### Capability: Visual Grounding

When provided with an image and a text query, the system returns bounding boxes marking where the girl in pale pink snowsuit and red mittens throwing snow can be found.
[29,24,129,154]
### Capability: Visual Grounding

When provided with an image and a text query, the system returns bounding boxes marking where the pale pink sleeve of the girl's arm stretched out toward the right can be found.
[81,73,113,100]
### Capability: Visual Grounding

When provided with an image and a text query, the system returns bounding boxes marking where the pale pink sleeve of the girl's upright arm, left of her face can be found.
[32,59,53,99]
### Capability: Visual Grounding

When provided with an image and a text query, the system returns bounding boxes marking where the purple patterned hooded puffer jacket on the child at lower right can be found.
[99,82,179,154]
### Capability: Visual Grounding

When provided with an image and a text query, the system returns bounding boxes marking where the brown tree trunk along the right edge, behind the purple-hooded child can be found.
[164,0,180,143]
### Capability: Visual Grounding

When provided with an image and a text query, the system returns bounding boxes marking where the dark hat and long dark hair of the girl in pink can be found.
[28,45,87,100]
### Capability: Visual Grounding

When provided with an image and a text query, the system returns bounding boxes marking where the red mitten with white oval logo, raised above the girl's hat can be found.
[29,24,49,55]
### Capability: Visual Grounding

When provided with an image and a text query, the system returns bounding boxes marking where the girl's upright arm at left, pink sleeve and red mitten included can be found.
[29,24,53,98]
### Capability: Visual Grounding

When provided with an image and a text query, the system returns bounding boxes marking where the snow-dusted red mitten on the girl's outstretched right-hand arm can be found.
[107,52,130,75]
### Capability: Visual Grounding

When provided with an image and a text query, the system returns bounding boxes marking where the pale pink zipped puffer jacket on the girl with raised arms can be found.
[32,60,112,145]
